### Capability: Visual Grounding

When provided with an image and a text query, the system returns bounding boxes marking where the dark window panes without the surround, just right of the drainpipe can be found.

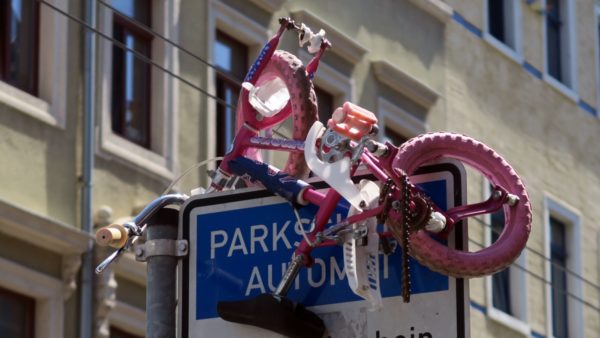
[112,0,152,148]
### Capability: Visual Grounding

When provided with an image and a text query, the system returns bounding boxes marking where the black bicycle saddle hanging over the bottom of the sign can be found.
[217,294,325,338]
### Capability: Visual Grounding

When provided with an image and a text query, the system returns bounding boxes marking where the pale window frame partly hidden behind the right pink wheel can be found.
[482,182,531,337]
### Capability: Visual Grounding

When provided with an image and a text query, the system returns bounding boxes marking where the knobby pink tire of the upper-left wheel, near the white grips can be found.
[236,50,318,178]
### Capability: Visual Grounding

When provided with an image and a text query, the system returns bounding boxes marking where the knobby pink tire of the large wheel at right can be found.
[393,133,531,278]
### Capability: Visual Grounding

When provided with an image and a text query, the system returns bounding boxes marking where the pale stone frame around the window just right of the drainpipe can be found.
[97,0,180,180]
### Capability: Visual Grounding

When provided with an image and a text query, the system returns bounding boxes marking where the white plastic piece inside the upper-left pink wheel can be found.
[242,77,290,117]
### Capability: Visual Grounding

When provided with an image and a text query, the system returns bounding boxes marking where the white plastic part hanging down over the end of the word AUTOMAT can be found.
[344,180,382,311]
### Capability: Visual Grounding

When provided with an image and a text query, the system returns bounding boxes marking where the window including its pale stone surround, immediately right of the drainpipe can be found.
[98,0,179,179]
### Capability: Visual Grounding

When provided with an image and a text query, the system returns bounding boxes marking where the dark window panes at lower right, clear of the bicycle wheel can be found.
[550,217,569,338]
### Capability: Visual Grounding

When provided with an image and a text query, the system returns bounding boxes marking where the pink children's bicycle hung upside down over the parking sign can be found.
[96,18,531,337]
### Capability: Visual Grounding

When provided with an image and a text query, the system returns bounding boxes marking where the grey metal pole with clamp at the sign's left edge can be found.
[144,209,182,338]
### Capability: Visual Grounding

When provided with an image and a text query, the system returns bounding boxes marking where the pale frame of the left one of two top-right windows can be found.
[482,0,524,64]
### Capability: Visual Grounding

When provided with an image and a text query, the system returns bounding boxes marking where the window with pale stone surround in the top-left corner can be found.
[0,0,69,128]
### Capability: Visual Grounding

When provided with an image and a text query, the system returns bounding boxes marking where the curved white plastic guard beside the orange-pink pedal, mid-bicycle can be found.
[304,121,362,210]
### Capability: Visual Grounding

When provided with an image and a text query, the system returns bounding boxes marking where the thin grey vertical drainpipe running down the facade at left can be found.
[79,0,97,338]
